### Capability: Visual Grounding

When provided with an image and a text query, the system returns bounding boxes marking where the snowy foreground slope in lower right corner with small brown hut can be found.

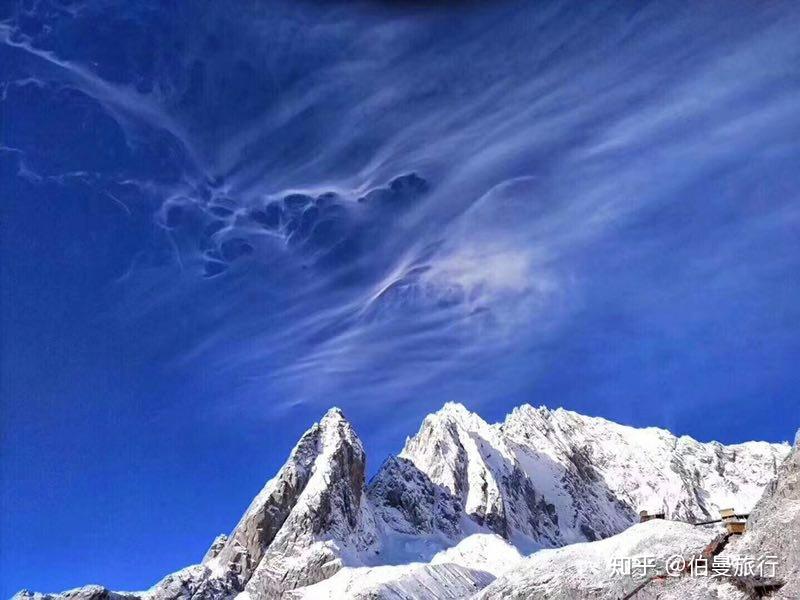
[473,438,800,600]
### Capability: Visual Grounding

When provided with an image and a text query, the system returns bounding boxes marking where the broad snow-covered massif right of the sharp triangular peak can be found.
[394,403,789,548]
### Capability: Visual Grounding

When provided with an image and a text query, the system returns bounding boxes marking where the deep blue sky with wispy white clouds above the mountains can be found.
[0,0,800,597]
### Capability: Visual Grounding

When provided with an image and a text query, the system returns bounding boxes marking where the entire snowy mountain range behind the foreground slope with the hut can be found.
[15,403,789,600]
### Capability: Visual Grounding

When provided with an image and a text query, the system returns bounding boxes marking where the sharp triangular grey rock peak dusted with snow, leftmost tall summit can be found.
[203,408,374,597]
